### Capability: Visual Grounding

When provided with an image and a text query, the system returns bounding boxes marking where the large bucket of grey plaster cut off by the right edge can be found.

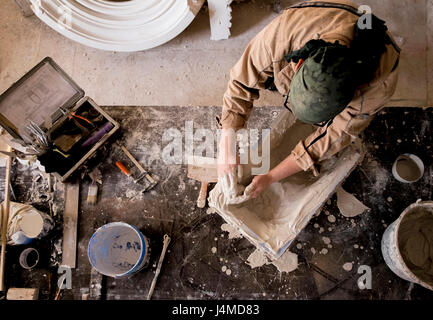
[381,201,433,290]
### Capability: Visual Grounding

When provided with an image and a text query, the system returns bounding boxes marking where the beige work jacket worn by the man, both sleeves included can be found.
[221,0,400,170]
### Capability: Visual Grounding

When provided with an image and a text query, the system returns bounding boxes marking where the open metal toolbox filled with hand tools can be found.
[0,57,120,182]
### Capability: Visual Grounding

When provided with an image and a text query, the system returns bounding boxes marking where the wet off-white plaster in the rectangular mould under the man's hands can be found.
[208,112,363,259]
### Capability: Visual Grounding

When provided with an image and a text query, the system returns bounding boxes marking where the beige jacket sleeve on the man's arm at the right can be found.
[292,47,398,171]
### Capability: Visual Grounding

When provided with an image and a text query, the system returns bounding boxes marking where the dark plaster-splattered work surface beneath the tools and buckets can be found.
[2,107,433,300]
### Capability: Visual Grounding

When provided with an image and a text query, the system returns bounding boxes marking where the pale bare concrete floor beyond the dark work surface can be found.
[0,0,433,106]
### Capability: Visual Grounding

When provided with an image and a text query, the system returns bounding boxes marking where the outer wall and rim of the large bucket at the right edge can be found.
[381,201,433,290]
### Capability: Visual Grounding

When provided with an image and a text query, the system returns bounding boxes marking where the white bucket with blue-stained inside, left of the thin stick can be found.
[87,222,150,278]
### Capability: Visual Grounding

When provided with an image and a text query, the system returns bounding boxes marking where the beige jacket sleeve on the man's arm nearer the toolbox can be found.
[221,24,272,130]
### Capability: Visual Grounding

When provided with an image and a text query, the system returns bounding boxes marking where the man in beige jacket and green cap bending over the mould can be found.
[218,0,400,198]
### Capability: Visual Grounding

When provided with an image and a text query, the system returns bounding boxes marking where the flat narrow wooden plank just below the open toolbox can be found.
[62,182,80,268]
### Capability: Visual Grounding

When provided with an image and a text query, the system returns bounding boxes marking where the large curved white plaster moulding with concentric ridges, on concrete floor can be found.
[30,0,204,52]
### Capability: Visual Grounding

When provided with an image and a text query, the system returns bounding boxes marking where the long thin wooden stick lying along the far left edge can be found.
[0,147,12,291]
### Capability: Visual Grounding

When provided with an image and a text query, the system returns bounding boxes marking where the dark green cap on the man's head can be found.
[289,44,357,124]
